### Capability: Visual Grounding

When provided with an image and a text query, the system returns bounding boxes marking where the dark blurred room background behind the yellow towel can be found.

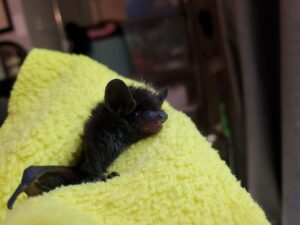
[0,0,300,225]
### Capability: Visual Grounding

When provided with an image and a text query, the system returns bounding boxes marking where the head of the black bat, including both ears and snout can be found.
[105,79,168,137]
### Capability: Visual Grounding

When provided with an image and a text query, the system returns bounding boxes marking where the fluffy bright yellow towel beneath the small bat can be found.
[0,50,269,225]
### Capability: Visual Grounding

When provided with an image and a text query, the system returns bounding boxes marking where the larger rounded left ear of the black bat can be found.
[104,79,136,114]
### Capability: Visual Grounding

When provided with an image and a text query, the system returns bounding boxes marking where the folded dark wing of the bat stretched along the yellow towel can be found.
[7,166,85,209]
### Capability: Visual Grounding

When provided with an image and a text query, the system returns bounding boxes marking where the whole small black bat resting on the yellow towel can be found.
[7,79,167,209]
